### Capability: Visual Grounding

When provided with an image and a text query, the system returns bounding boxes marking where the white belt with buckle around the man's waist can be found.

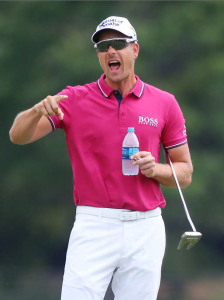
[76,205,161,221]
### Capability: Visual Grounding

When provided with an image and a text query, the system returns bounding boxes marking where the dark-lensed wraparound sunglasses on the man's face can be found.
[94,38,136,52]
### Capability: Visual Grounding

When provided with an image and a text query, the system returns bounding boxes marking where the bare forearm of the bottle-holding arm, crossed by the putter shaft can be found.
[152,162,193,187]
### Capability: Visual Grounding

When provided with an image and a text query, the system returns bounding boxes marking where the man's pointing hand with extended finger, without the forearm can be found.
[34,95,68,120]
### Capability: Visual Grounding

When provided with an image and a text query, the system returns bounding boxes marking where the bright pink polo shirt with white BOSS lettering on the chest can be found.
[49,74,187,211]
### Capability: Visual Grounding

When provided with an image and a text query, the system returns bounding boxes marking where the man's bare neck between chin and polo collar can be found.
[104,74,137,98]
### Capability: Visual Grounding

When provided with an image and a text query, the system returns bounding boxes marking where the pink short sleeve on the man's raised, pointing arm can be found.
[48,86,73,130]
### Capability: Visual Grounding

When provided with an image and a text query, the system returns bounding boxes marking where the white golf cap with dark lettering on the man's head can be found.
[91,16,137,43]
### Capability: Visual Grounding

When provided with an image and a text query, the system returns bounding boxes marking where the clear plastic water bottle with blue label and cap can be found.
[122,127,139,175]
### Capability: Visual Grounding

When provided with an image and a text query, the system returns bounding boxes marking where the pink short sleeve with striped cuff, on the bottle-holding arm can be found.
[161,96,187,149]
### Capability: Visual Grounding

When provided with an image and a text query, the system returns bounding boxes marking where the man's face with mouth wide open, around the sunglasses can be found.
[97,29,139,83]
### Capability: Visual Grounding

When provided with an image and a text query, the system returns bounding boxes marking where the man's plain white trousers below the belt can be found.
[61,207,166,300]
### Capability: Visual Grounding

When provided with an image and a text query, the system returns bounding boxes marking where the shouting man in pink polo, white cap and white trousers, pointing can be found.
[10,17,193,300]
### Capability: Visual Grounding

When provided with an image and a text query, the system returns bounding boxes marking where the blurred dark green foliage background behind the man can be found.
[0,1,224,300]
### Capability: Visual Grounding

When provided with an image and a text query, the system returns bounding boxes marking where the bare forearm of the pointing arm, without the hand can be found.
[9,107,42,145]
